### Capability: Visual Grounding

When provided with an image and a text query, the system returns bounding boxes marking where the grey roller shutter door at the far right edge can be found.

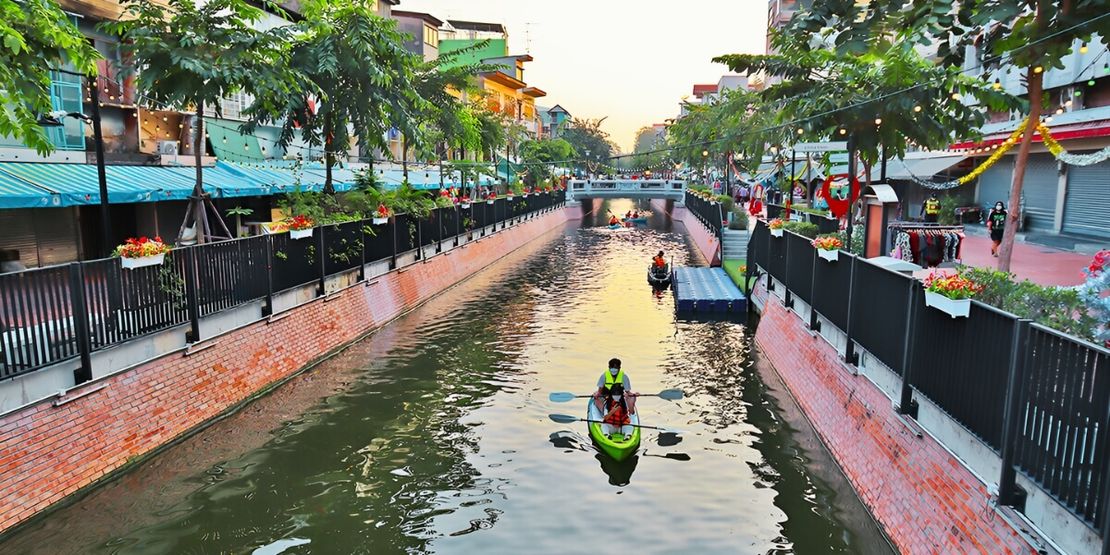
[1062,160,1110,239]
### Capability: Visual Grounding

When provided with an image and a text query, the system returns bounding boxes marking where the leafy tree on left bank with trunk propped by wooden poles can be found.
[103,0,300,243]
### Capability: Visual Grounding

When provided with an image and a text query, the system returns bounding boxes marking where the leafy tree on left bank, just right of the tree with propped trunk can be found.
[251,0,426,193]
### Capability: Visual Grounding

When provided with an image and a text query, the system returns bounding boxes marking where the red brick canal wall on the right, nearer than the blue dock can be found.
[756,285,1035,554]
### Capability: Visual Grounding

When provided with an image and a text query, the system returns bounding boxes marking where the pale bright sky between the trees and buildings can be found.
[396,0,767,151]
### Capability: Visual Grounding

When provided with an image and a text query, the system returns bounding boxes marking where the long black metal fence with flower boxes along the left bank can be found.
[0,192,564,383]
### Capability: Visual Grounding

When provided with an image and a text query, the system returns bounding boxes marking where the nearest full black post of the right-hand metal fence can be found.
[998,319,1030,508]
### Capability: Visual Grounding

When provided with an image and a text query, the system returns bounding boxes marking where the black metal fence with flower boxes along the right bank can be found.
[748,223,1110,537]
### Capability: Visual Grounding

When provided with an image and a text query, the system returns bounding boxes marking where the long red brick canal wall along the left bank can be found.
[0,209,567,532]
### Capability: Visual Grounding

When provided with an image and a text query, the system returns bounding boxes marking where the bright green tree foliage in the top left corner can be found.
[0,0,99,154]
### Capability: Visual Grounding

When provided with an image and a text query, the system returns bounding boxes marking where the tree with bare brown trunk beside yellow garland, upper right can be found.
[788,0,1110,271]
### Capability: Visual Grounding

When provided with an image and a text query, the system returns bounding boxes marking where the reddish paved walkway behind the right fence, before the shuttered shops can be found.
[917,233,1093,285]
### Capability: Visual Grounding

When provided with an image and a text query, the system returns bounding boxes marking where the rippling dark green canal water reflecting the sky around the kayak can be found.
[0,201,883,555]
